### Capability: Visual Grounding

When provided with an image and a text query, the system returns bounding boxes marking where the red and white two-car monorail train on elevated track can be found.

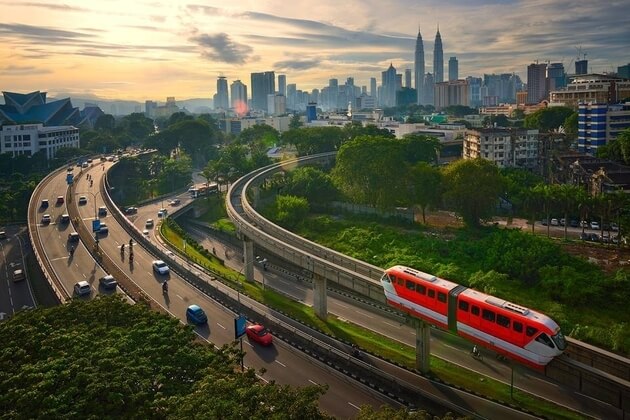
[381,265,567,369]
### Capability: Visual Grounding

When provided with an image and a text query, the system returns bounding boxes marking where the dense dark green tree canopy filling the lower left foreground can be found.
[0,295,327,419]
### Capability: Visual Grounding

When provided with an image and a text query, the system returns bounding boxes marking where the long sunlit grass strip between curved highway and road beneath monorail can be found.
[160,223,583,420]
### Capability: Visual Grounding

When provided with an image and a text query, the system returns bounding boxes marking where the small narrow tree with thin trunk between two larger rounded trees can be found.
[408,162,442,224]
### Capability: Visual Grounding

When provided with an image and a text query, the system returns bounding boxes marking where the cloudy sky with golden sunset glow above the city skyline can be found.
[0,0,630,102]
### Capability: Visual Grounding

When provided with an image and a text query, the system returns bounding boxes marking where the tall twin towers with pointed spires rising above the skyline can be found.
[415,26,444,105]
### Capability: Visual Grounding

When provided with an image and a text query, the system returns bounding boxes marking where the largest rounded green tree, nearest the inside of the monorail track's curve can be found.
[332,136,407,208]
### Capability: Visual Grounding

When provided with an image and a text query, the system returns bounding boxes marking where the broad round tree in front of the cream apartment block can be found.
[444,159,505,227]
